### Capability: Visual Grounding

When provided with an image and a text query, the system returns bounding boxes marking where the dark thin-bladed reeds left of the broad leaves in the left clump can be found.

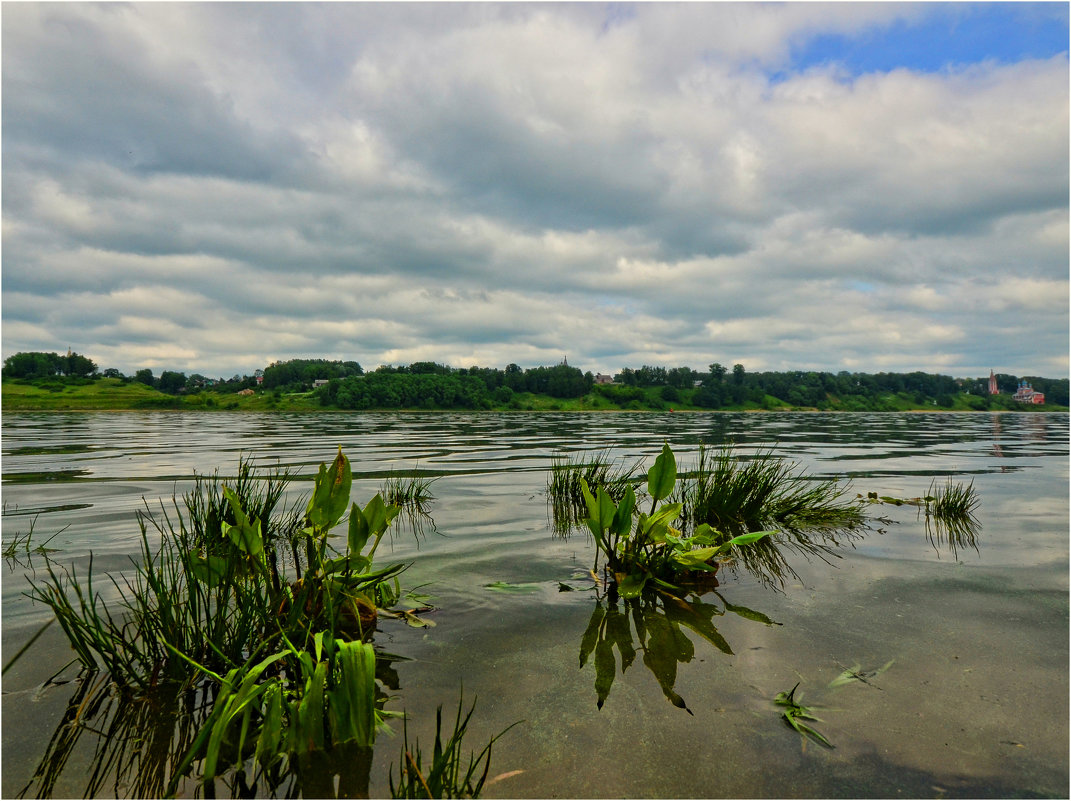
[30,462,301,691]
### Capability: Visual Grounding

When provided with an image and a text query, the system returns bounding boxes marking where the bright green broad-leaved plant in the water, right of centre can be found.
[580,444,774,598]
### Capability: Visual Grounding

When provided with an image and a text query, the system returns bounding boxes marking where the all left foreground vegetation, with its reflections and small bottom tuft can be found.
[17,450,494,798]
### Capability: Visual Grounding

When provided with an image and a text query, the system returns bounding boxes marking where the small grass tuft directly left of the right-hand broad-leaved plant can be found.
[546,451,639,535]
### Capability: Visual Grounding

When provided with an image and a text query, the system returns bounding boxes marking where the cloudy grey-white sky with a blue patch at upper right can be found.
[2,2,1069,377]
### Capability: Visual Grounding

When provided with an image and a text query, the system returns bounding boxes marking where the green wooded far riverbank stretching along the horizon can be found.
[3,352,1068,411]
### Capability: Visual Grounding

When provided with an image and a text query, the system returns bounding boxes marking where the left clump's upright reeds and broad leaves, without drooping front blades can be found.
[30,451,405,690]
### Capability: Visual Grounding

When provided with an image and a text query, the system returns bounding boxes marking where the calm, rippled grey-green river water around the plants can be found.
[2,413,1069,798]
